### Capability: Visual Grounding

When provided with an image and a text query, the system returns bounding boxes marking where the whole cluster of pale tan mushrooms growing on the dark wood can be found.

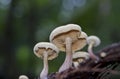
[19,24,100,79]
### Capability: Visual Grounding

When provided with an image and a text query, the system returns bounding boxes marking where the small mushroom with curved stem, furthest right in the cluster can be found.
[87,36,101,61]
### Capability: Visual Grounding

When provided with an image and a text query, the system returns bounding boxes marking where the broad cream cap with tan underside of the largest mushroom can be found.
[50,24,85,51]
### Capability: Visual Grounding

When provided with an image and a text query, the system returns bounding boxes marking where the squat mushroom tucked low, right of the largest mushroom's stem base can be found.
[72,51,90,67]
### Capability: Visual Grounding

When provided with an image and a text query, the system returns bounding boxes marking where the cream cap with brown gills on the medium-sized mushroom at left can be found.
[33,42,59,60]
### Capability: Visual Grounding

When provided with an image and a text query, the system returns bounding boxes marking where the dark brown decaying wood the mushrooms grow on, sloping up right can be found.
[48,43,120,79]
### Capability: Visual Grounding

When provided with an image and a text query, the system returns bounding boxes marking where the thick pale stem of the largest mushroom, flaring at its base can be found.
[59,37,72,72]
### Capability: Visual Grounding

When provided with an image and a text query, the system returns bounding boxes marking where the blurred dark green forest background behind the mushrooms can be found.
[0,0,120,79]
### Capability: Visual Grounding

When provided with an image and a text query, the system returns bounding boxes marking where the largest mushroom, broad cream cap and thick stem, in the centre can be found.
[50,24,86,72]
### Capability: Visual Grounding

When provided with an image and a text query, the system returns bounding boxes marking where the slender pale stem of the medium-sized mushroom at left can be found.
[40,51,48,79]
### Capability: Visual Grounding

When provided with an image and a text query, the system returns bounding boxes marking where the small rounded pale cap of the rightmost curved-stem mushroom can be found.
[87,35,101,47]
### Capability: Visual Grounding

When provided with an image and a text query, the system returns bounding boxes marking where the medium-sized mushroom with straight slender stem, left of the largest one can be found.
[34,42,59,79]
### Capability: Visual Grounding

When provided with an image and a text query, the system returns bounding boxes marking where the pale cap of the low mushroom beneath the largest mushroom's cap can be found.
[72,51,90,60]
